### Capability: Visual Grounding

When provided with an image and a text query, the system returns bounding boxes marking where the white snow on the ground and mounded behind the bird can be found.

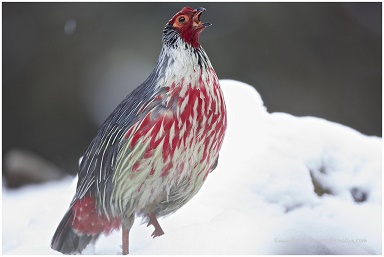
[2,80,382,255]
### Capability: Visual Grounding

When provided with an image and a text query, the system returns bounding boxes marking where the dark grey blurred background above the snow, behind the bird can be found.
[2,2,382,187]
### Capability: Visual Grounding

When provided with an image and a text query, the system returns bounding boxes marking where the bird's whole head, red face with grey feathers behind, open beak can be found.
[164,7,212,48]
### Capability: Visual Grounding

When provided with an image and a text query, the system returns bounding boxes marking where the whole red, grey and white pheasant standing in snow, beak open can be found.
[51,6,227,255]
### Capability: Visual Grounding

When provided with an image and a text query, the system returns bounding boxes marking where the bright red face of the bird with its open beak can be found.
[168,7,211,47]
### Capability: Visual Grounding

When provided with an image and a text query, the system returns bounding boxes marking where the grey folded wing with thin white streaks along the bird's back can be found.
[75,80,166,199]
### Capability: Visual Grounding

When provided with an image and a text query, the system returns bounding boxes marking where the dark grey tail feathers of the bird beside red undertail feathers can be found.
[51,208,100,254]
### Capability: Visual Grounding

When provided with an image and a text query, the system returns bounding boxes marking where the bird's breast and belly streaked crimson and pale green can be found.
[110,69,226,213]
